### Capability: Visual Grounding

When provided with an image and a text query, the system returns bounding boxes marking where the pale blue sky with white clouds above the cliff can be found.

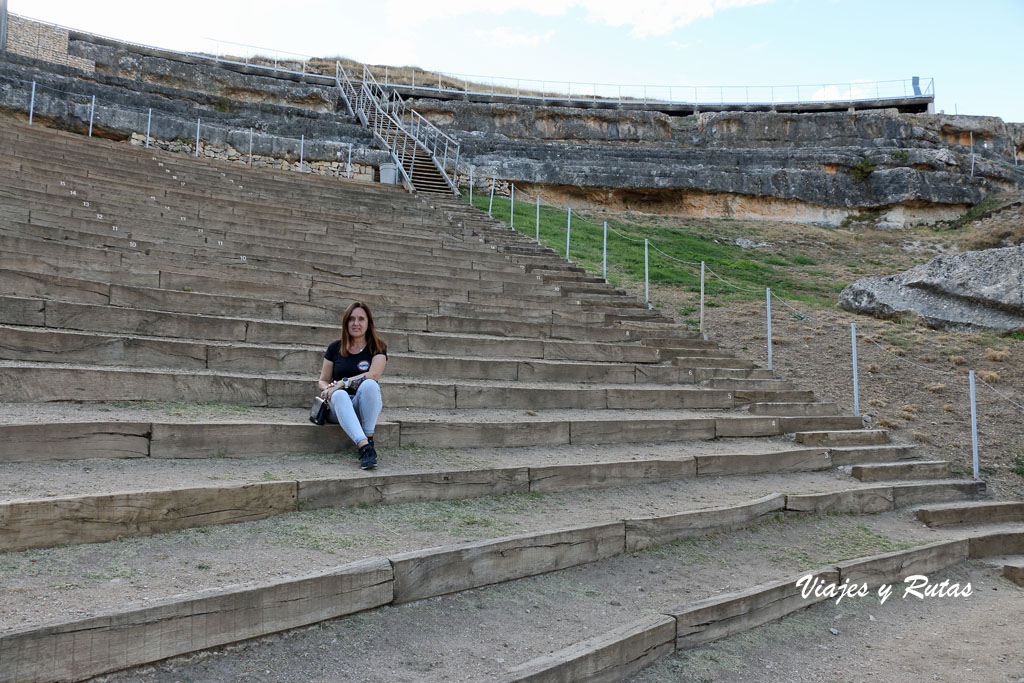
[7,0,1024,122]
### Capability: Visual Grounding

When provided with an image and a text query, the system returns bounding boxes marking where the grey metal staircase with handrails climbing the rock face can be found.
[335,61,459,197]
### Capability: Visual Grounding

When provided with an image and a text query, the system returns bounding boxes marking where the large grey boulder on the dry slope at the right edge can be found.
[839,247,1024,331]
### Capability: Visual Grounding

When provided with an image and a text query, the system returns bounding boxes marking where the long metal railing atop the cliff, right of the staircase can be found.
[378,67,935,105]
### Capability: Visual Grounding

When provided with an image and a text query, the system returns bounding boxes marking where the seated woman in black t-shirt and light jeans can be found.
[316,301,387,470]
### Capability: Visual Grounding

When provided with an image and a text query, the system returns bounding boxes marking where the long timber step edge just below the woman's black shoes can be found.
[0,450,864,552]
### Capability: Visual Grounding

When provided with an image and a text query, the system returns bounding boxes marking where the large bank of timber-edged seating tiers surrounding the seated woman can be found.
[0,121,1007,680]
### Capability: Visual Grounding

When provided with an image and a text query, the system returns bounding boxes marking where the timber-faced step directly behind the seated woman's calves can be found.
[0,407,864,463]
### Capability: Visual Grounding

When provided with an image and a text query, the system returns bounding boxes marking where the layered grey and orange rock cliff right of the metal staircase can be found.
[413,98,1024,227]
